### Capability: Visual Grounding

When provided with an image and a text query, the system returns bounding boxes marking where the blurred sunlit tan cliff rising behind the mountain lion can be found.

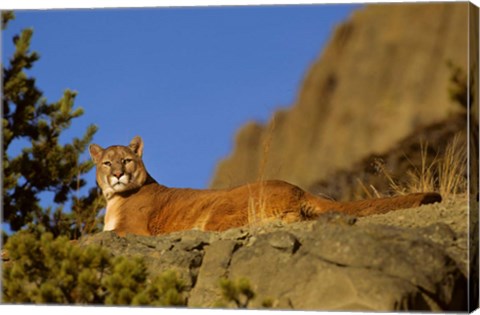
[211,3,469,189]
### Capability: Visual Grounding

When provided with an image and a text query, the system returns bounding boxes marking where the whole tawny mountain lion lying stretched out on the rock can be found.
[89,137,441,235]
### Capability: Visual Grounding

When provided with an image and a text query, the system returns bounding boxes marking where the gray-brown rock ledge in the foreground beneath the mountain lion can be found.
[81,203,468,311]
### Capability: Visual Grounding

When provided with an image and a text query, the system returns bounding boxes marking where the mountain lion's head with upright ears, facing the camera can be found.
[89,136,149,200]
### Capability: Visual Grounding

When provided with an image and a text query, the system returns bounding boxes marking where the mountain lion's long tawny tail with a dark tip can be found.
[340,192,442,216]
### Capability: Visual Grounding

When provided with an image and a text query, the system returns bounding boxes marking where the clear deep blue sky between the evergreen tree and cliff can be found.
[2,4,359,196]
